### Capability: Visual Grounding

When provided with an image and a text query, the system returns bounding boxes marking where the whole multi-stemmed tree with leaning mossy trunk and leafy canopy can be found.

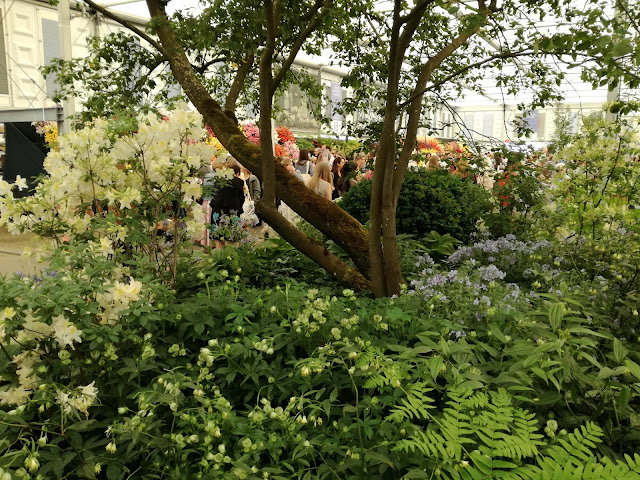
[69,0,598,296]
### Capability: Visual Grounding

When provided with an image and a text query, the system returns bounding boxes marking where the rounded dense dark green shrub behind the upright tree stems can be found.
[340,169,492,242]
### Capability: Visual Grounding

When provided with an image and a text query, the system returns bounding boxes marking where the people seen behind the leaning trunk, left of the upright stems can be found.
[199,145,372,248]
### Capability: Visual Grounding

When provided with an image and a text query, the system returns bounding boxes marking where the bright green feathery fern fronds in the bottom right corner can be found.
[396,390,640,480]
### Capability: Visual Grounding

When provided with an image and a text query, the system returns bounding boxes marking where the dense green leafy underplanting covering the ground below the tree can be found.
[0,238,640,480]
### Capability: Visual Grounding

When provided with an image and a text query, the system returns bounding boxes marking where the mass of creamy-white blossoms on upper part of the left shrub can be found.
[0,109,215,244]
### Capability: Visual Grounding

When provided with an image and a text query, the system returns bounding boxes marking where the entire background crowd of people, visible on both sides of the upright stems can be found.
[191,137,556,247]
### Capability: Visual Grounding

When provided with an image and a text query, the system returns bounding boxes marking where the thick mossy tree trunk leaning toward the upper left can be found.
[147,0,370,290]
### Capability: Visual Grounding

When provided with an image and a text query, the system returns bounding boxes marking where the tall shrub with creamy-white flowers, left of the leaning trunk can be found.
[0,110,215,281]
